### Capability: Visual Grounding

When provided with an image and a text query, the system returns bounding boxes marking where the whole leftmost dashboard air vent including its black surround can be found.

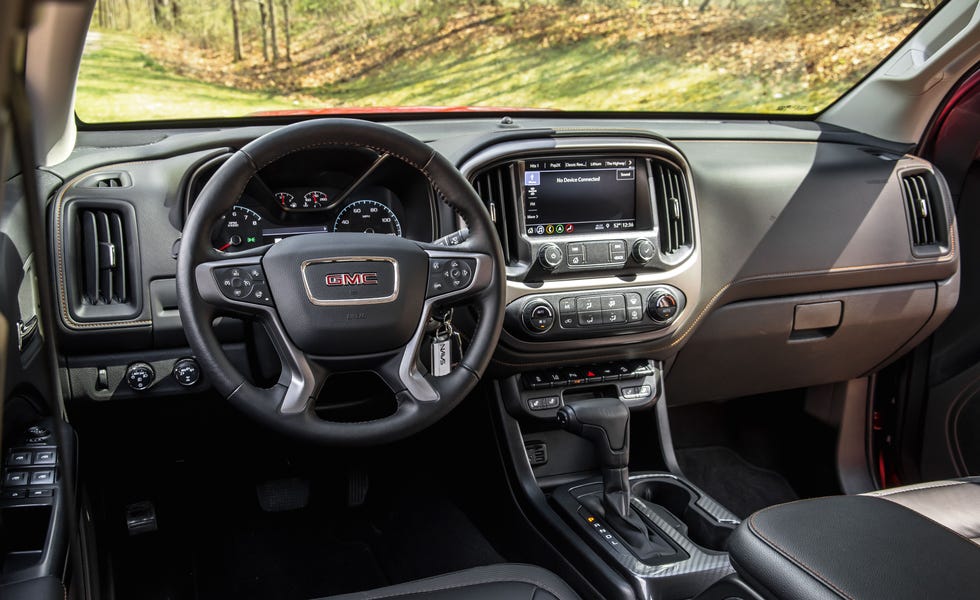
[57,198,142,327]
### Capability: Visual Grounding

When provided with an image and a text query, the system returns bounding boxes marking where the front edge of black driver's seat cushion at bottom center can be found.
[323,564,579,600]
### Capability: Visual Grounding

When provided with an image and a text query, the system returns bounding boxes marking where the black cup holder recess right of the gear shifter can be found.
[633,477,735,552]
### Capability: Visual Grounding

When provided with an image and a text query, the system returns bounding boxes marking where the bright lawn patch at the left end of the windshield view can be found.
[75,33,296,123]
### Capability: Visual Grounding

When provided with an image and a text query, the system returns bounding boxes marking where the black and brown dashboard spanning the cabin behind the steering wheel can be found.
[36,117,959,403]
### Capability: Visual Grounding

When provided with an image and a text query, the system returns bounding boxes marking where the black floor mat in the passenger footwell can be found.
[677,446,798,519]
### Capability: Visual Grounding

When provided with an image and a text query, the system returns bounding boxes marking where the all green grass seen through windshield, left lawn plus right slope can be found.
[76,33,848,122]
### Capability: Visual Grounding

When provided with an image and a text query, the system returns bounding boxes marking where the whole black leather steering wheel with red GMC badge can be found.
[177,119,504,446]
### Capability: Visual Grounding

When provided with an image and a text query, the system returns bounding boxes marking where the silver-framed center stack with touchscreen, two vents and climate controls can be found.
[463,138,700,346]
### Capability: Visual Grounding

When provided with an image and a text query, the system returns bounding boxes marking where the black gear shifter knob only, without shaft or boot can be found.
[558,398,630,470]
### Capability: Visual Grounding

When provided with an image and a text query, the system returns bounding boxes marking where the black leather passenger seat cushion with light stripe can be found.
[728,478,980,600]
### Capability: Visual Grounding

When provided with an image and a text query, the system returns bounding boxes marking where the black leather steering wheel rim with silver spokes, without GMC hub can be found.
[177,119,505,446]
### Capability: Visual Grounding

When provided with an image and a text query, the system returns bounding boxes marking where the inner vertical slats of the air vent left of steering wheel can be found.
[78,209,129,305]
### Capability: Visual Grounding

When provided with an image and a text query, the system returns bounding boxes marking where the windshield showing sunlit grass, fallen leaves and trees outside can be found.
[76,0,929,123]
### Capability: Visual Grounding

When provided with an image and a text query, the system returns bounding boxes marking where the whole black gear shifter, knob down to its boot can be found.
[558,398,673,558]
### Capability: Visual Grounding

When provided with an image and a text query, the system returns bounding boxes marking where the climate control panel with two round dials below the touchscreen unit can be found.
[507,285,686,341]
